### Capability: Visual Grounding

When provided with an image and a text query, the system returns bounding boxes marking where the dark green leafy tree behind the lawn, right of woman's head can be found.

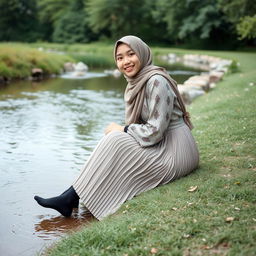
[154,0,238,48]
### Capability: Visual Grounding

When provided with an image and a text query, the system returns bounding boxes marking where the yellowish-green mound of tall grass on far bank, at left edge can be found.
[0,43,73,80]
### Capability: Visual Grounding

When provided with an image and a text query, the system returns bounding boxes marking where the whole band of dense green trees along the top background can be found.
[0,0,256,48]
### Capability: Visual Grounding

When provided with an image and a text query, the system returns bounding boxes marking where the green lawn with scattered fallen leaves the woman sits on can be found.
[46,49,256,256]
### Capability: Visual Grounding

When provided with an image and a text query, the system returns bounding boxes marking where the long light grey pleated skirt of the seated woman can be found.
[73,125,199,220]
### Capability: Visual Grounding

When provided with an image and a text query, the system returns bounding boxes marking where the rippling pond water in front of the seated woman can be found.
[0,70,198,256]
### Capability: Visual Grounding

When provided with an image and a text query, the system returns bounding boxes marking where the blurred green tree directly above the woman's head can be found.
[86,0,162,40]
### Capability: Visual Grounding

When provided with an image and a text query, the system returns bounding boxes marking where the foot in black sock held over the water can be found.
[34,186,79,217]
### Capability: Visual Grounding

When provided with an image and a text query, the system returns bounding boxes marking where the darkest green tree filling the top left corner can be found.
[0,0,40,41]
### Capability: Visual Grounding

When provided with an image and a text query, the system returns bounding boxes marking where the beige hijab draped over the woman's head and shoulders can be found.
[114,36,193,129]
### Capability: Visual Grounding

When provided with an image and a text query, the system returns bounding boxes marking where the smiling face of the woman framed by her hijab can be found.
[116,43,141,77]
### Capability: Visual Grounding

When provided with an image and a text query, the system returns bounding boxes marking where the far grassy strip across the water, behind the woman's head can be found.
[0,42,240,82]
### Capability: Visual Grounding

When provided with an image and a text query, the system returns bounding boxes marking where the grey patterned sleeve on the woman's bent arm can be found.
[127,75,175,147]
